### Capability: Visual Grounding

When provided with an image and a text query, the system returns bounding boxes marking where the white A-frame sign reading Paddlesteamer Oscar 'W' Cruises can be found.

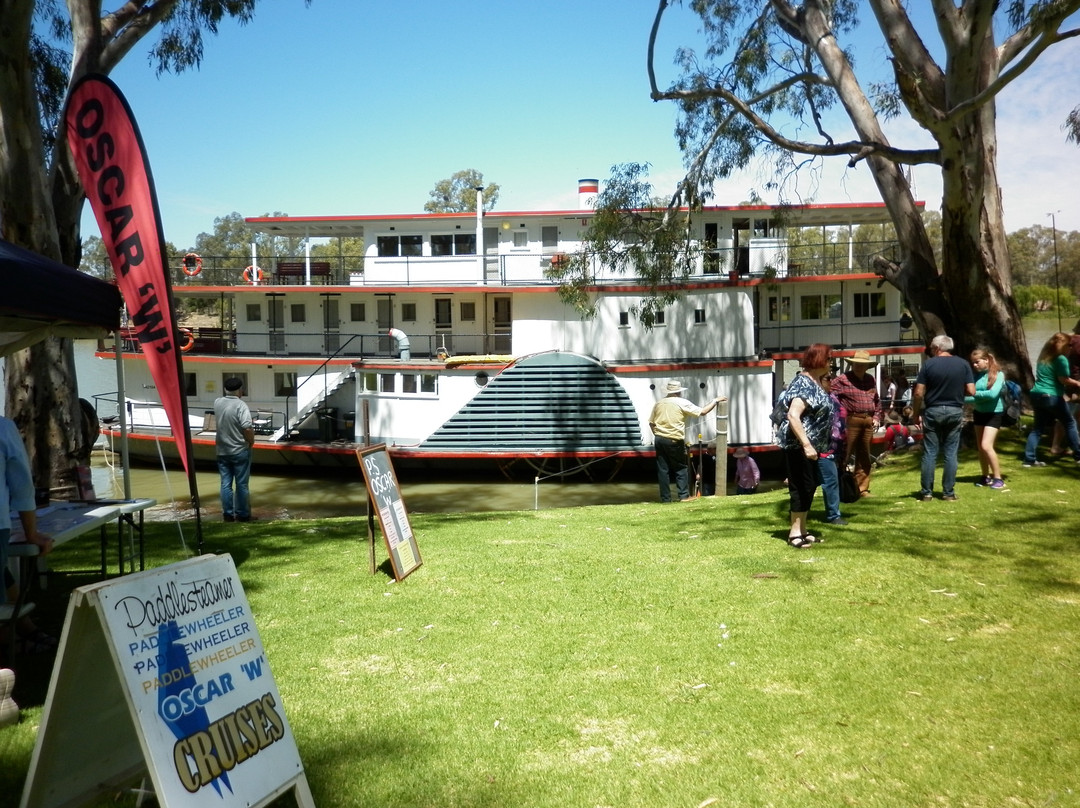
[19,555,314,808]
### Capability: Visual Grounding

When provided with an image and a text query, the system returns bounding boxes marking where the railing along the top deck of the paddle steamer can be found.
[150,238,900,294]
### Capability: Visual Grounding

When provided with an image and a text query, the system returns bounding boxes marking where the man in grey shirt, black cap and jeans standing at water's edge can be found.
[214,376,255,522]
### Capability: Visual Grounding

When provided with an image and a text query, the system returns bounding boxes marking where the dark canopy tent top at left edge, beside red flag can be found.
[0,239,123,356]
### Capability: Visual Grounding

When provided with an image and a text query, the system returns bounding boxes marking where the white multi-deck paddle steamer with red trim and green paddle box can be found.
[98,180,922,475]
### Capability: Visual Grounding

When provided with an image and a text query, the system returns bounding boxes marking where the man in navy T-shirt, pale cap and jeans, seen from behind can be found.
[912,334,975,502]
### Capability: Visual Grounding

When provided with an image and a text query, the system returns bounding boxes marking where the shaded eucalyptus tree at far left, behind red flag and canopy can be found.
[0,0,310,485]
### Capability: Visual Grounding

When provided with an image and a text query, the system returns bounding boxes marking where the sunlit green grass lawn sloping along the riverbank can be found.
[0,430,1080,808]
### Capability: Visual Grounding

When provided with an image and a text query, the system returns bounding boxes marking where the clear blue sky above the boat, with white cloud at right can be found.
[95,0,1080,248]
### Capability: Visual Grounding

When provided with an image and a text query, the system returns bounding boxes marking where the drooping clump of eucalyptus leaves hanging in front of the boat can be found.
[544,163,691,328]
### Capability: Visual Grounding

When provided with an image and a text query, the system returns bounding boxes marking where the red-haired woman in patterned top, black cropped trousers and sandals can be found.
[778,342,833,549]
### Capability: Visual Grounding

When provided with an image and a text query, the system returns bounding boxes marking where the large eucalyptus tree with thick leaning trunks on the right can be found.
[561,0,1080,380]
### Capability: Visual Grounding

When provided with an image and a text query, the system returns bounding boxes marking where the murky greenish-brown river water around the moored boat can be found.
[0,320,1057,519]
